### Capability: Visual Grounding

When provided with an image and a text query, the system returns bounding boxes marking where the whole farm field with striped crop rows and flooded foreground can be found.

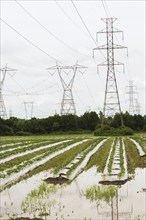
[0,134,146,220]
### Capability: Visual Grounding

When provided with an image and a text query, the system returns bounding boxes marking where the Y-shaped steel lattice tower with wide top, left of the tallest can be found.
[47,64,86,115]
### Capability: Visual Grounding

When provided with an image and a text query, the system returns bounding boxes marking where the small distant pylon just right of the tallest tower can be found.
[125,80,137,115]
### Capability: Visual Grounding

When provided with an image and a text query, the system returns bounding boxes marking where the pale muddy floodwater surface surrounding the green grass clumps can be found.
[0,167,146,220]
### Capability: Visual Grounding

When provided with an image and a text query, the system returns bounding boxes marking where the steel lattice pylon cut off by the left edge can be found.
[0,65,16,119]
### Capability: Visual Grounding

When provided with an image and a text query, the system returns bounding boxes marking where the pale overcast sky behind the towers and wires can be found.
[1,0,146,118]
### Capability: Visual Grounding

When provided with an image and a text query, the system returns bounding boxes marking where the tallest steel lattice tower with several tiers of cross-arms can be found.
[93,18,127,124]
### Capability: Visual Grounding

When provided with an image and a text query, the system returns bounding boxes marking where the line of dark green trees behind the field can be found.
[0,111,146,135]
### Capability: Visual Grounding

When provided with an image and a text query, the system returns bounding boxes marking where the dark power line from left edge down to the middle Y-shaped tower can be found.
[0,18,62,64]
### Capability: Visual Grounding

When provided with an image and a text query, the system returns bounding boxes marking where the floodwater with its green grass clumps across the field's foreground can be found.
[0,167,146,220]
